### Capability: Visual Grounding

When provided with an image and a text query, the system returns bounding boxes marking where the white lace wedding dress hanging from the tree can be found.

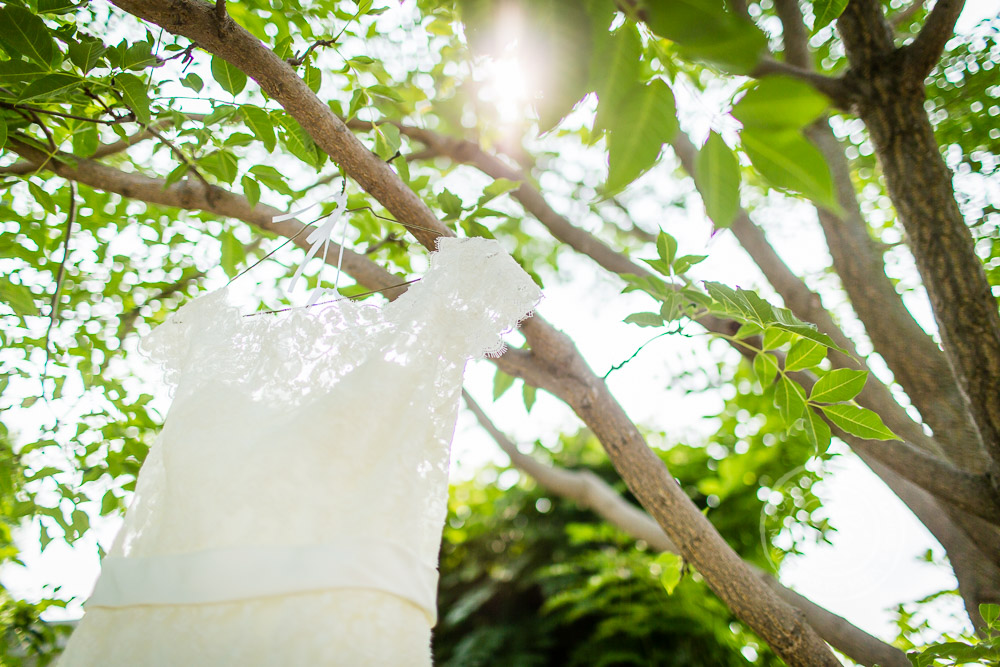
[60,238,540,667]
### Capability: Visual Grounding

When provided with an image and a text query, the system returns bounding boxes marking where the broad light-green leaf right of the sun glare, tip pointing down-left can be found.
[606,79,678,192]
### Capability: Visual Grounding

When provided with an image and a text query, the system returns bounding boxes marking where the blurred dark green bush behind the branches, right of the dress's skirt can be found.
[434,433,802,665]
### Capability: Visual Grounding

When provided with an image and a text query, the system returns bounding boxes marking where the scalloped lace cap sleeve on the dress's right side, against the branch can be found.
[422,237,542,358]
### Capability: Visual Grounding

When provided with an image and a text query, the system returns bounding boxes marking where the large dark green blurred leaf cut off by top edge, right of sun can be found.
[643,0,767,74]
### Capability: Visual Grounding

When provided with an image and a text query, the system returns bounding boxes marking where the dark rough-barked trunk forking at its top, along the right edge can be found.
[839,0,1000,480]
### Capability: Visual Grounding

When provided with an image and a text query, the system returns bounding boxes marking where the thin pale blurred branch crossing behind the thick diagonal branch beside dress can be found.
[462,390,910,667]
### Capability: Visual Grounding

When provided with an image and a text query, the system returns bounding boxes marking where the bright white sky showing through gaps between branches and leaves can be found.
[0,0,1000,656]
